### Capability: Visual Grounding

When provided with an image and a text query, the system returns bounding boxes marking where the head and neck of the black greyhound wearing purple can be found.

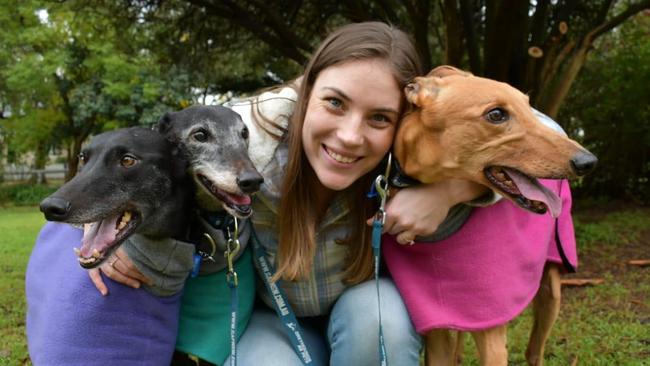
[40,127,193,268]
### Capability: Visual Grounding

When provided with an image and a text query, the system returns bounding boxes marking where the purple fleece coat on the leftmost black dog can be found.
[26,222,181,366]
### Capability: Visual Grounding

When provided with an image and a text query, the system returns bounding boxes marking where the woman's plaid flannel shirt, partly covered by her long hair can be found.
[251,143,491,316]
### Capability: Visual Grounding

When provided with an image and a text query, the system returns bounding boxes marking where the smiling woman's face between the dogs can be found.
[302,59,401,191]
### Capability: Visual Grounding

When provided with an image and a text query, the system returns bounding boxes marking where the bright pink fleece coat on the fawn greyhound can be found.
[382,180,577,334]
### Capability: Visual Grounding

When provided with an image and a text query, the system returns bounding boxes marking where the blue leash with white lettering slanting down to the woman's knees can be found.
[251,227,313,365]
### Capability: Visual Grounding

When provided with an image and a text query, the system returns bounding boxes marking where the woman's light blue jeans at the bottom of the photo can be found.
[225,278,421,366]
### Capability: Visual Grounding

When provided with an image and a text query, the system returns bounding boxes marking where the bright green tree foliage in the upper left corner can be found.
[0,0,192,172]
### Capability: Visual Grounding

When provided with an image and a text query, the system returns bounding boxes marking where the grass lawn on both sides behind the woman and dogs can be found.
[0,207,650,366]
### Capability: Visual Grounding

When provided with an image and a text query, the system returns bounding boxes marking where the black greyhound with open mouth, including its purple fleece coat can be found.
[25,128,194,366]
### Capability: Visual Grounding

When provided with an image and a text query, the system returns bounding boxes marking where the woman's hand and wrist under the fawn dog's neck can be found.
[367,179,488,244]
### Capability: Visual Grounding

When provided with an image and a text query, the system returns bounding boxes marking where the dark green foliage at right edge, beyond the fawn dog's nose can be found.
[560,15,650,202]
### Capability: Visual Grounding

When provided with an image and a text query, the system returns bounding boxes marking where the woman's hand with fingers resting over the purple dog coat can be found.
[88,248,153,296]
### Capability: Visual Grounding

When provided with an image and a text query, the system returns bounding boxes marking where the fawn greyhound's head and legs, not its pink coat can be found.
[387,66,597,365]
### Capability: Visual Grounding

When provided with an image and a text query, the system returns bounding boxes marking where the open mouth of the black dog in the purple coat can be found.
[75,211,140,268]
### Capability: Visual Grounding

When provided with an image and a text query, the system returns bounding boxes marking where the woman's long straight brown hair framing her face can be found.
[275,22,422,283]
